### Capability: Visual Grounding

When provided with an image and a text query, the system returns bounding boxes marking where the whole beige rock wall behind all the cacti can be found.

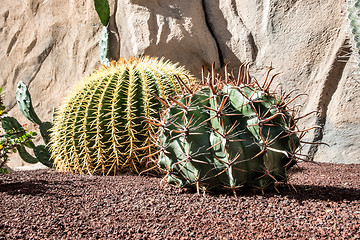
[0,0,360,168]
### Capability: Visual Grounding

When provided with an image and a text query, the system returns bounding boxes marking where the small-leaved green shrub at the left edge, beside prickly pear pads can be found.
[0,88,37,173]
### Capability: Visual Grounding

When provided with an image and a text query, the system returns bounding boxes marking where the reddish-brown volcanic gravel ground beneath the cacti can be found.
[0,163,360,239]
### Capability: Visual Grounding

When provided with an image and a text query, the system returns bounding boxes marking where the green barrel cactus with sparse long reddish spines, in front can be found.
[151,65,302,193]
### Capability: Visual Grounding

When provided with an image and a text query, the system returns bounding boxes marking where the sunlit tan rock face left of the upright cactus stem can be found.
[0,0,101,167]
